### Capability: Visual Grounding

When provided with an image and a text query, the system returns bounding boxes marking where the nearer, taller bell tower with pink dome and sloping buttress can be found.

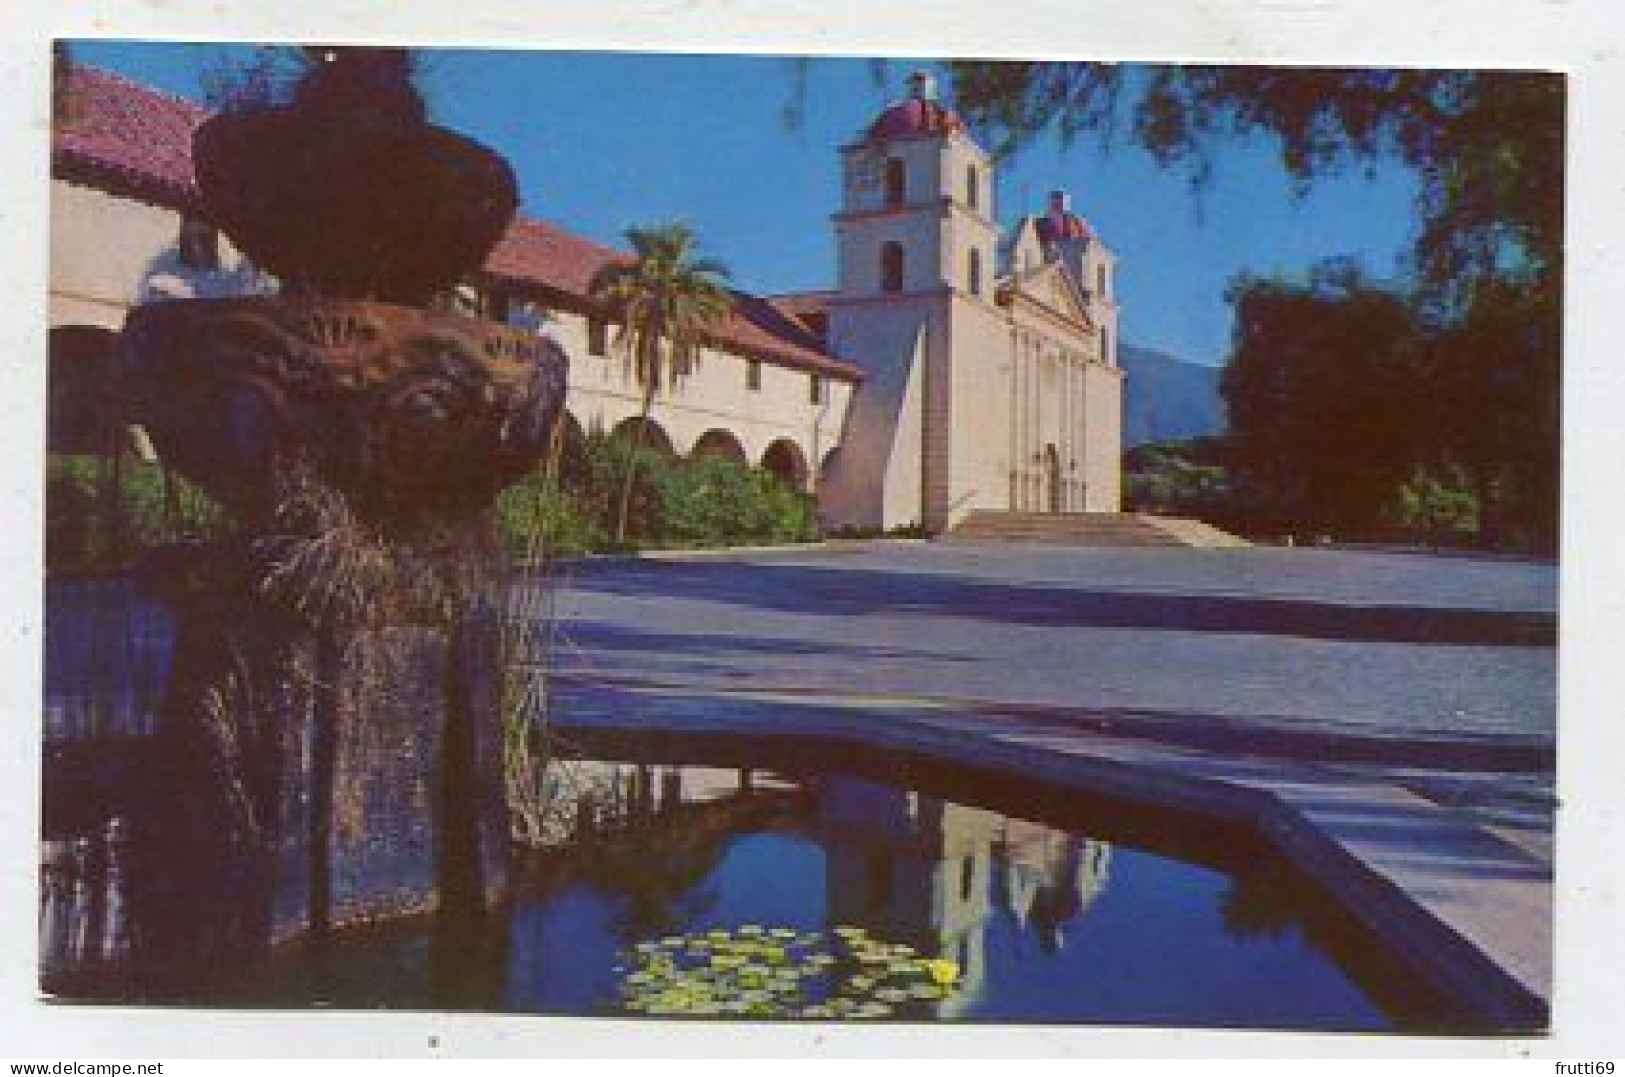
[822,71,999,533]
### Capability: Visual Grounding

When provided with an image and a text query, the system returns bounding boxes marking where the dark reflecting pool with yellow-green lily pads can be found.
[41,760,1451,1030]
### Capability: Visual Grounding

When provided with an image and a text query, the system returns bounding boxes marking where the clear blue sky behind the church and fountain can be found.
[75,42,1415,364]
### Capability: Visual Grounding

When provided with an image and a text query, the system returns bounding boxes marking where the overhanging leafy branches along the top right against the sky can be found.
[949,60,1563,304]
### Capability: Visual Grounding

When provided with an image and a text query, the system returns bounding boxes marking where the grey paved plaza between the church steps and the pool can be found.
[557,544,1557,749]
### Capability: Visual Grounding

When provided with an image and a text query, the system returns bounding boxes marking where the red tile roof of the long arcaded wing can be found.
[54,65,863,380]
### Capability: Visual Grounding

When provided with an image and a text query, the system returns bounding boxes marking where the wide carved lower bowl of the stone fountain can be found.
[122,299,569,536]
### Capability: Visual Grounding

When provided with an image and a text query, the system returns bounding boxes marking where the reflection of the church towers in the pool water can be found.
[817,778,1112,1017]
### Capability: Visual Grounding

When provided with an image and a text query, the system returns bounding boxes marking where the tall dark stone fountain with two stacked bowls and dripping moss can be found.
[120,49,567,960]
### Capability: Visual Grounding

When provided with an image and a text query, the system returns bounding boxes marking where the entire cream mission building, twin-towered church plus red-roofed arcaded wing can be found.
[49,65,1123,534]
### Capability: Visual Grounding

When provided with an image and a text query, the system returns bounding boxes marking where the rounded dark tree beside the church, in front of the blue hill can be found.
[1220,266,1430,538]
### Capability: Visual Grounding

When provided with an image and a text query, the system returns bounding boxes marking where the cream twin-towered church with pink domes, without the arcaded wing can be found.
[819,73,1123,533]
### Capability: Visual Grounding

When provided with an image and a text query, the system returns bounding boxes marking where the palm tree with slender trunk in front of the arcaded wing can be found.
[588,223,733,543]
